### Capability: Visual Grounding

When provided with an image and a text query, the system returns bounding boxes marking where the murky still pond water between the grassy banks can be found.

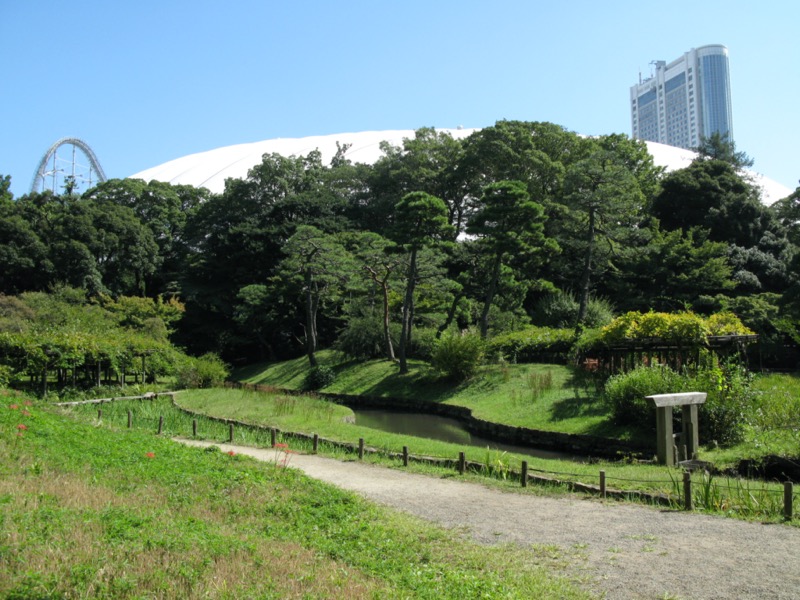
[352,408,585,461]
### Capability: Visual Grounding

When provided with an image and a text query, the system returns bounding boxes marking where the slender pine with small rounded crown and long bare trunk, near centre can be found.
[392,192,454,374]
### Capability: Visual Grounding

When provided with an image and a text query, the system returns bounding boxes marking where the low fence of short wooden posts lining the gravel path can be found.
[58,392,795,520]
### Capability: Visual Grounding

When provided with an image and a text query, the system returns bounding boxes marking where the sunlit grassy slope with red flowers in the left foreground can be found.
[0,395,584,598]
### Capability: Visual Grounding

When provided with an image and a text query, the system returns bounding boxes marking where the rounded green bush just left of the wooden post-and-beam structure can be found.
[602,367,684,429]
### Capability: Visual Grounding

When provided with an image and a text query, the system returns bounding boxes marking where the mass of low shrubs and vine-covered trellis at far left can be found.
[0,288,228,395]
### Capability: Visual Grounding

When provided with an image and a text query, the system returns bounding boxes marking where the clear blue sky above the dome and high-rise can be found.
[0,0,800,196]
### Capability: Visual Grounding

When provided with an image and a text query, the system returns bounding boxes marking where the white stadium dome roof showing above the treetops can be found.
[130,128,792,204]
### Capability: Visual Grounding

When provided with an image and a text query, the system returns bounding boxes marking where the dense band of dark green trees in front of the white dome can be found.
[0,121,800,368]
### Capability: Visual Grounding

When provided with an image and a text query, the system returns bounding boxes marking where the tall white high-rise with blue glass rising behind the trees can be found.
[631,44,733,149]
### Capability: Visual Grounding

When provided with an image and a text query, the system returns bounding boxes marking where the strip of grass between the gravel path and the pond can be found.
[61,389,800,521]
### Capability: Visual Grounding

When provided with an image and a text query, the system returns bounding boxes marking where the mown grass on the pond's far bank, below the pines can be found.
[234,351,800,469]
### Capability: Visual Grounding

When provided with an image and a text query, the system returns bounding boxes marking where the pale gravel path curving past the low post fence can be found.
[180,440,800,600]
